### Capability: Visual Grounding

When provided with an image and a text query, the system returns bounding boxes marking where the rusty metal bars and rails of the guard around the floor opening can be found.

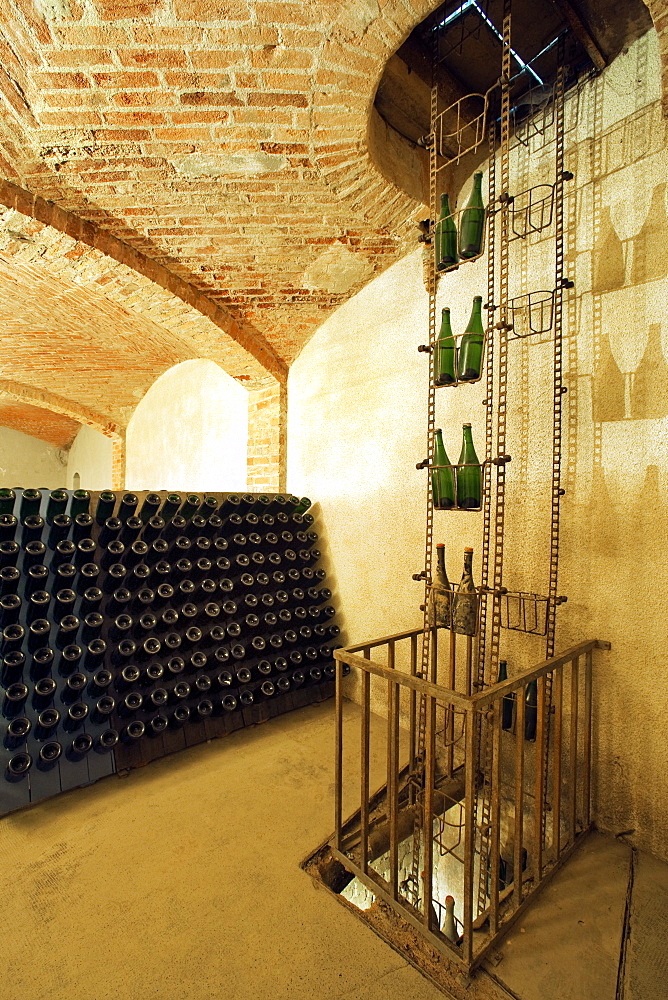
[330,628,610,972]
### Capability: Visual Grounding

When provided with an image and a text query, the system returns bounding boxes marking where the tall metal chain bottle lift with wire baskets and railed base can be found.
[308,0,608,972]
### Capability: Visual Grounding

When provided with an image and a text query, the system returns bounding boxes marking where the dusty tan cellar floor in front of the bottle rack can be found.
[0,701,668,1000]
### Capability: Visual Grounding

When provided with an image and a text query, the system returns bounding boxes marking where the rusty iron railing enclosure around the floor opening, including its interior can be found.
[330,628,610,972]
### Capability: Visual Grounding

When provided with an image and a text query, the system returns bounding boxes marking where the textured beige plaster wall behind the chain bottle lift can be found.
[288,32,668,857]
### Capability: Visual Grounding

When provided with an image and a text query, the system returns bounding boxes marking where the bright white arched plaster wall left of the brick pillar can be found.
[126,360,248,491]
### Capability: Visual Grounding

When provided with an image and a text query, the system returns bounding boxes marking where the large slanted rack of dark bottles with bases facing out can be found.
[0,488,339,813]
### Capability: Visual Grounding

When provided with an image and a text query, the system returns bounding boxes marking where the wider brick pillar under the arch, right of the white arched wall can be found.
[248,382,287,492]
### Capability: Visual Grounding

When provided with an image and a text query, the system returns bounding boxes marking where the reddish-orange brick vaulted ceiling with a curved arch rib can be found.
[0,0,665,446]
